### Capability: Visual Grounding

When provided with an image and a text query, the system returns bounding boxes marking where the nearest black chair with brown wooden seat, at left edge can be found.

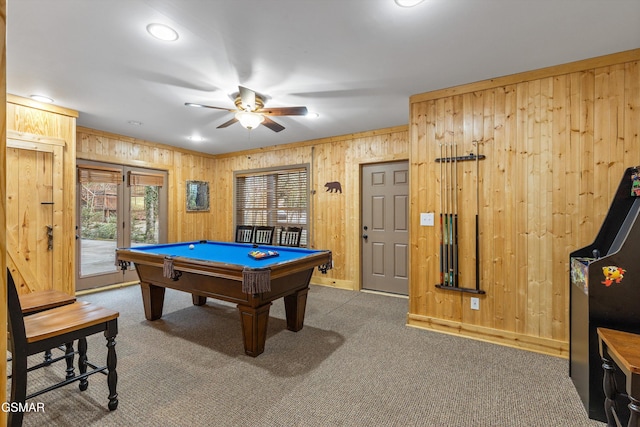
[7,270,119,426]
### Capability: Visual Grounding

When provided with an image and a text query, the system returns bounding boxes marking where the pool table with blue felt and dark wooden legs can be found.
[116,240,332,357]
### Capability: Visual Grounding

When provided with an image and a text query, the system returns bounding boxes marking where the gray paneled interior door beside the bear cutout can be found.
[361,162,409,295]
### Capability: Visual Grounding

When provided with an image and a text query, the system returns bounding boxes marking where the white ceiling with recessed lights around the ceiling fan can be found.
[7,0,640,154]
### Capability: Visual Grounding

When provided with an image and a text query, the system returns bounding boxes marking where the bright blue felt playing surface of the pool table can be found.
[130,240,324,268]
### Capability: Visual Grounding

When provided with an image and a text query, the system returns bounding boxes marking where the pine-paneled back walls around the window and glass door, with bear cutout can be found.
[77,126,409,289]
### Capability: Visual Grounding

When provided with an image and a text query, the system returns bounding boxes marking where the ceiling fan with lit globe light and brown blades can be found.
[184,86,307,132]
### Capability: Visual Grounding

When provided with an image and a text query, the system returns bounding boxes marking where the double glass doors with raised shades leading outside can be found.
[76,160,167,290]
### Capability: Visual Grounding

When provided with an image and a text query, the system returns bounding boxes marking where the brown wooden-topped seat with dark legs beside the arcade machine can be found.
[598,328,640,427]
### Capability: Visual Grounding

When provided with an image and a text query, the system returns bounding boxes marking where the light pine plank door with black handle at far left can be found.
[6,139,64,293]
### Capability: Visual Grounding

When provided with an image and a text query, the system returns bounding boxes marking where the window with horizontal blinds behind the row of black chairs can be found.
[235,165,309,246]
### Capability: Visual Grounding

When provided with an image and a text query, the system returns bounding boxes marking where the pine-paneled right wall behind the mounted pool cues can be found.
[408,49,640,356]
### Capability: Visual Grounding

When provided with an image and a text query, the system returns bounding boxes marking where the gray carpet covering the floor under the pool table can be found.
[13,286,604,427]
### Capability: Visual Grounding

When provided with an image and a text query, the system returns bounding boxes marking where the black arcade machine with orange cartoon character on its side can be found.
[569,166,640,425]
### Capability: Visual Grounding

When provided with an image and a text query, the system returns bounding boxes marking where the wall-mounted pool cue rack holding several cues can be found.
[435,145,486,294]
